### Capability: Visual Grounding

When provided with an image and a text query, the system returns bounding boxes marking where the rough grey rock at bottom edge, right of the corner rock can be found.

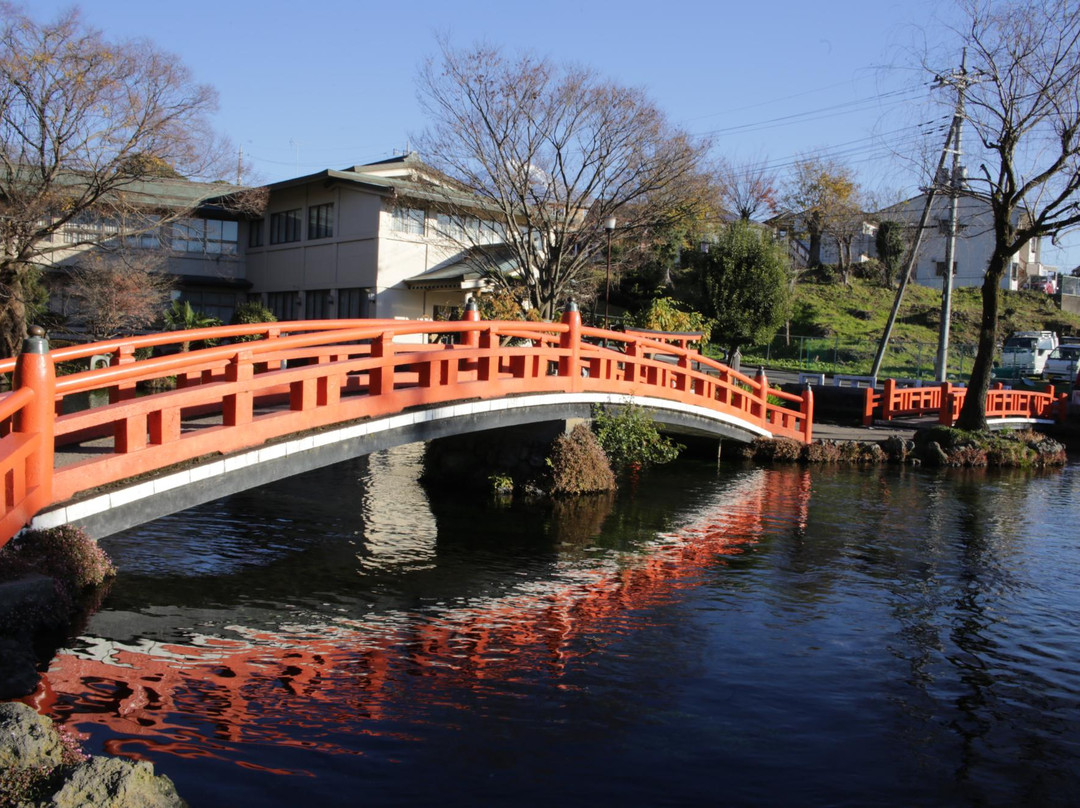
[48,757,187,808]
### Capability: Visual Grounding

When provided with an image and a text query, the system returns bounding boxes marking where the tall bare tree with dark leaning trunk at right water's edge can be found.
[934,0,1080,430]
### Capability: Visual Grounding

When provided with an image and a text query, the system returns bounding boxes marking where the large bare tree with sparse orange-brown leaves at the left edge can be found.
[0,3,222,355]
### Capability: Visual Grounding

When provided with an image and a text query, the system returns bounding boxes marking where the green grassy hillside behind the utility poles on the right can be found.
[748,280,1080,378]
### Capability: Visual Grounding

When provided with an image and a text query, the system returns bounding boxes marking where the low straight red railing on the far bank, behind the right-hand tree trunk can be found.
[863,379,1068,427]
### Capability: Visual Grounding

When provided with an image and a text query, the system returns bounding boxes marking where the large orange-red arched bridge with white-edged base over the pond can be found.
[0,310,813,546]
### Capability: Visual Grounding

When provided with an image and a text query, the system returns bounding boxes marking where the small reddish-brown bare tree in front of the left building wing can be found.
[67,251,173,340]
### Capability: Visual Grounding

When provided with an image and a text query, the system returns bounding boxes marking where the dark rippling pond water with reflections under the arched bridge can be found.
[27,446,1080,808]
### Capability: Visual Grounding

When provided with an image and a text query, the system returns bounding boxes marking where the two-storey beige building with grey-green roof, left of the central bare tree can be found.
[242,156,501,320]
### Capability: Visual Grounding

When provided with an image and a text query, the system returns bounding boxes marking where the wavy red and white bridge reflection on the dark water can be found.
[29,468,810,775]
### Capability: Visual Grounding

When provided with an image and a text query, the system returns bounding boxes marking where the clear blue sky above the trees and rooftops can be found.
[26,0,1080,267]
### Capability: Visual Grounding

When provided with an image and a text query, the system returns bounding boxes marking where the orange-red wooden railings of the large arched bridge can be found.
[0,310,813,546]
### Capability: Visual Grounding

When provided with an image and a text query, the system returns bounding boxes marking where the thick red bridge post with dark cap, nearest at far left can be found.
[13,325,56,502]
